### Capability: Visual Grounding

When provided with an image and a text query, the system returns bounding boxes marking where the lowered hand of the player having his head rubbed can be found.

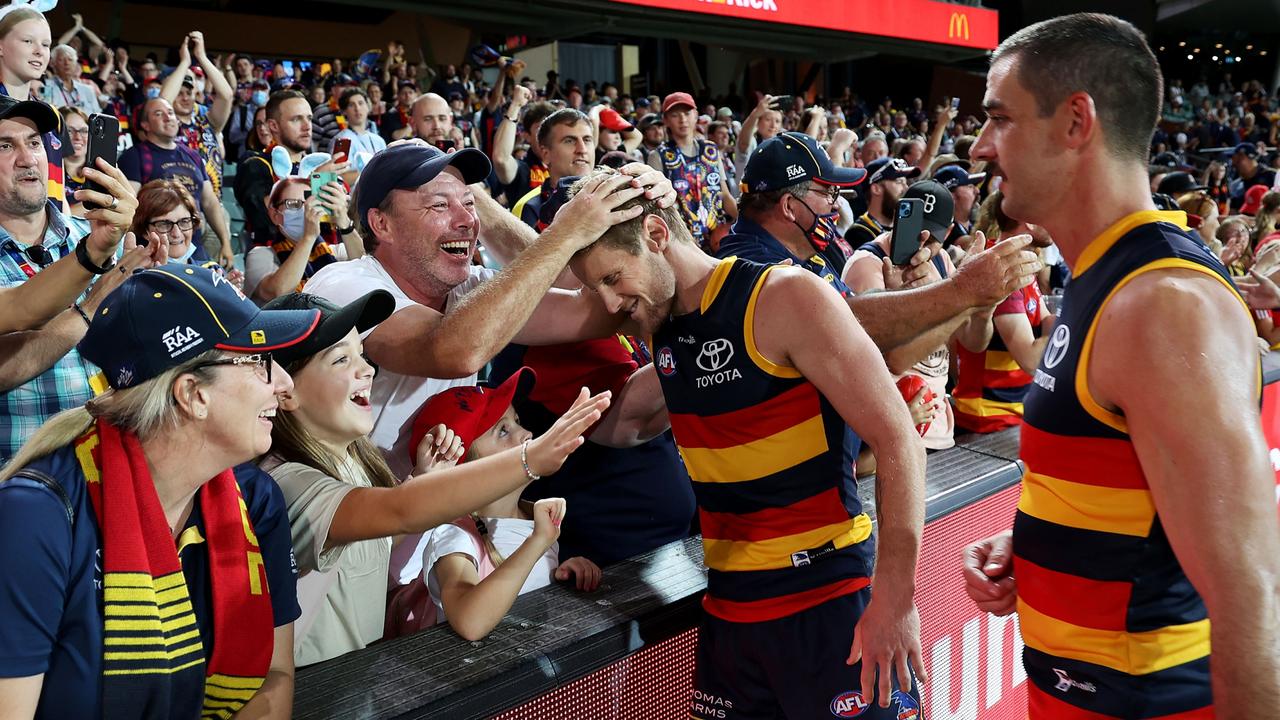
[846,596,929,707]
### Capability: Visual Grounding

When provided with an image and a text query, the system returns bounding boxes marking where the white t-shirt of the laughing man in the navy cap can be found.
[306,255,498,479]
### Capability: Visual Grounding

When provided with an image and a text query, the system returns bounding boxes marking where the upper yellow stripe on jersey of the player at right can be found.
[1018,471,1156,538]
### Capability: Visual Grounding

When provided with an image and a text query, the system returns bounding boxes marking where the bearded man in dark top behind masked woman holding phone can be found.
[236,90,311,246]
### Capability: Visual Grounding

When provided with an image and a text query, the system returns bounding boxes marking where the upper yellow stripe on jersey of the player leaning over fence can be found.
[680,415,827,483]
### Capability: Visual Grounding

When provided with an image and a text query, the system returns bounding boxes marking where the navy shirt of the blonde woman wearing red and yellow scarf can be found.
[0,446,301,719]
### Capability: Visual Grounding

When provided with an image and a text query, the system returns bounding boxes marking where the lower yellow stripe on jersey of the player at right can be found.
[1018,598,1210,675]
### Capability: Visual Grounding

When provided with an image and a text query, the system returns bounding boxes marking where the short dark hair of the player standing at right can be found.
[991,13,1164,163]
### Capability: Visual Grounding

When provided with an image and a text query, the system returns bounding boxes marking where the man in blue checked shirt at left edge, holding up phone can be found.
[0,97,147,461]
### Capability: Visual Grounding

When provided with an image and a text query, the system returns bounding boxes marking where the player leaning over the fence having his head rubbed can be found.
[570,163,925,720]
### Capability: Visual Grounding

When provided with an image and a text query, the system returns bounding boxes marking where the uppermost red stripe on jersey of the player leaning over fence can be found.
[671,383,822,450]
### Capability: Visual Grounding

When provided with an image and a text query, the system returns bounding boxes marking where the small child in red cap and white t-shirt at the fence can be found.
[410,368,600,641]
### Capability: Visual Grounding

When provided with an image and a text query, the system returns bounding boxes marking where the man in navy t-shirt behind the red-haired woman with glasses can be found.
[120,97,236,268]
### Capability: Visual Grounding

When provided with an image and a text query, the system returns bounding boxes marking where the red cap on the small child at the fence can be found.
[408,368,538,462]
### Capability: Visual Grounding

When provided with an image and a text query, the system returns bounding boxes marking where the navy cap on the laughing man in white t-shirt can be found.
[355,142,493,222]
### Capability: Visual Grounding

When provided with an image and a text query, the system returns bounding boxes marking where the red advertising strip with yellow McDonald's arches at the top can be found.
[612,0,1000,50]
